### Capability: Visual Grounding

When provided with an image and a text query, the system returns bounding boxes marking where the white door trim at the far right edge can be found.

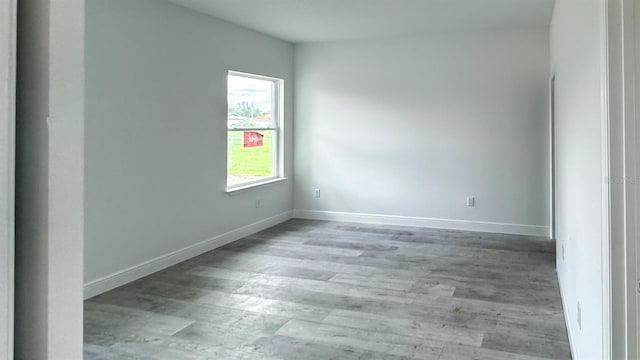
[602,0,640,360]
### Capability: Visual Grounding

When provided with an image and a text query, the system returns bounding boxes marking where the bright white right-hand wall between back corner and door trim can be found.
[551,0,606,360]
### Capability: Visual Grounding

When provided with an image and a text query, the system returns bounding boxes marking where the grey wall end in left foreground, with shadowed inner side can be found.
[15,0,84,359]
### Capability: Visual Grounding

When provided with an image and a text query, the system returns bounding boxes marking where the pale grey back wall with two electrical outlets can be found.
[294,29,549,234]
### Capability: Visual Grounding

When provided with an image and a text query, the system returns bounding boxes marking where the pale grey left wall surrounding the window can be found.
[84,0,293,283]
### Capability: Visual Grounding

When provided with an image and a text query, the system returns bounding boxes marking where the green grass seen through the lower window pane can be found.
[227,131,273,176]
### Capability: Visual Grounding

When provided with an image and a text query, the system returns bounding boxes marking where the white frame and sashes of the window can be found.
[225,70,286,193]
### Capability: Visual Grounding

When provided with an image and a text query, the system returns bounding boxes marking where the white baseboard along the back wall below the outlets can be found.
[293,210,549,238]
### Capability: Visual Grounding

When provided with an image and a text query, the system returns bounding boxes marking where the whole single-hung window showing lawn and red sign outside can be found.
[227,71,283,190]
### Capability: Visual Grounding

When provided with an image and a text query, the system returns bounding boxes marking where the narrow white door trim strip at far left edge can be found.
[0,0,16,359]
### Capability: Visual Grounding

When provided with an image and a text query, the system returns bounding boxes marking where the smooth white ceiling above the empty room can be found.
[169,0,554,43]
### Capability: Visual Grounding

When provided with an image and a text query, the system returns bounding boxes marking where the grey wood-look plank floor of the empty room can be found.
[85,220,571,360]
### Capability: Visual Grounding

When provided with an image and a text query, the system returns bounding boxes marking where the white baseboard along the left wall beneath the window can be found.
[84,211,292,299]
